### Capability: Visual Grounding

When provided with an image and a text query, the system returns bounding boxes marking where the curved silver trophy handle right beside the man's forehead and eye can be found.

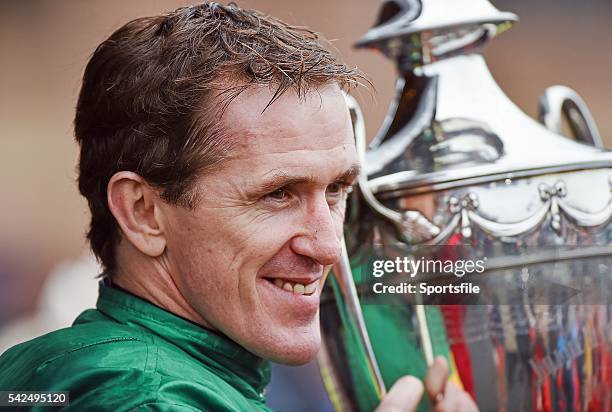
[344,94,440,243]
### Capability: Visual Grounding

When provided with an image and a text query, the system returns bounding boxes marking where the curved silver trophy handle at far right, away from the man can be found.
[539,86,604,149]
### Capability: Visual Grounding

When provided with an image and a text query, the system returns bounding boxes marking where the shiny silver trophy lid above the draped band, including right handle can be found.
[357,0,612,197]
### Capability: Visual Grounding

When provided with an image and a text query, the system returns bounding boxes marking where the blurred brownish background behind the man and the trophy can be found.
[0,0,612,410]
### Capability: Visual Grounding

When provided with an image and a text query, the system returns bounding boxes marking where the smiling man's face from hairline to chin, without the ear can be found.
[160,86,358,364]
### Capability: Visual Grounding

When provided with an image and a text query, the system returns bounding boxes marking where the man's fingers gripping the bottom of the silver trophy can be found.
[376,357,478,412]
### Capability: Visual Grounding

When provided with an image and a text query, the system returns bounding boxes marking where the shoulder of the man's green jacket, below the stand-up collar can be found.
[0,310,265,411]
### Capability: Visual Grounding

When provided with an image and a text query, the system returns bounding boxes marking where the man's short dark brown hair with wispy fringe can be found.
[74,3,364,275]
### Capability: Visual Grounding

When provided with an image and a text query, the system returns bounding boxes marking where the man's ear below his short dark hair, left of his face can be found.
[106,171,166,257]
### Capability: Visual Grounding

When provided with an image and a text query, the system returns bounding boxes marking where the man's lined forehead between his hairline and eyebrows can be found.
[216,85,356,177]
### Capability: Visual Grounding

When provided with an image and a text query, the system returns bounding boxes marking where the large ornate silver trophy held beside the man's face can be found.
[319,0,612,411]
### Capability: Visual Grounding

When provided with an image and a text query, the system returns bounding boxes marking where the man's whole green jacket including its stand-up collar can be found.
[0,282,270,412]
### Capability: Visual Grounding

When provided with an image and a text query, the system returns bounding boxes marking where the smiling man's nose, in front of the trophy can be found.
[290,196,342,266]
